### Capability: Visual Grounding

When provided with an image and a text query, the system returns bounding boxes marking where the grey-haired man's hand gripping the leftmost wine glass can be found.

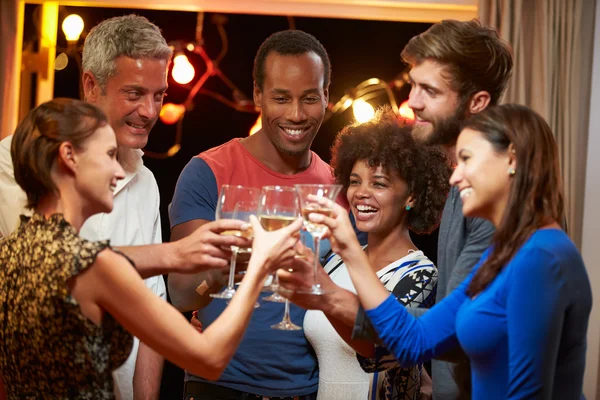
[173,219,251,274]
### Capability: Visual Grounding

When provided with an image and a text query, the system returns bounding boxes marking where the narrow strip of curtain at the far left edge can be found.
[0,0,23,139]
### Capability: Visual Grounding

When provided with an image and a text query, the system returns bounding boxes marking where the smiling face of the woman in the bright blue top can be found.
[450,129,516,226]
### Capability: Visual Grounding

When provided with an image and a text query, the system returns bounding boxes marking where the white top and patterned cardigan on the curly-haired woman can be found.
[304,246,437,400]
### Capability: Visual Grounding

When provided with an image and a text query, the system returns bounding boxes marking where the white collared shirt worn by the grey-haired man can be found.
[0,136,167,400]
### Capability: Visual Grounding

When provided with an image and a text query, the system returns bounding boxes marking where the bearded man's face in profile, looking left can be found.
[408,60,467,146]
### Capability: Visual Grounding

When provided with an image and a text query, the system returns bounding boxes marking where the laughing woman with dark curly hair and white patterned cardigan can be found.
[282,108,450,400]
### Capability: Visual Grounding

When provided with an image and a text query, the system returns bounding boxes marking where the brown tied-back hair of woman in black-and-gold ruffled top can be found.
[10,98,108,208]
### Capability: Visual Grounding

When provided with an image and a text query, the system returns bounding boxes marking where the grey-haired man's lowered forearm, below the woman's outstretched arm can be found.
[133,342,164,400]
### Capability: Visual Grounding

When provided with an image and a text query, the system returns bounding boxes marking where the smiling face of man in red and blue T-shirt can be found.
[254,52,328,156]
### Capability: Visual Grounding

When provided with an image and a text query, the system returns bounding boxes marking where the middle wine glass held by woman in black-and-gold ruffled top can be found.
[258,186,300,303]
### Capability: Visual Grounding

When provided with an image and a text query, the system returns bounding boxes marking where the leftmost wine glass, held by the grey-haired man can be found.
[210,185,260,299]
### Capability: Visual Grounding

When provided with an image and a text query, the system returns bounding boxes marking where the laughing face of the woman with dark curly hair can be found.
[347,160,413,233]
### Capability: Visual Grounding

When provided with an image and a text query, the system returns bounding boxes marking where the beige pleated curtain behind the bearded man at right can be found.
[478,0,596,248]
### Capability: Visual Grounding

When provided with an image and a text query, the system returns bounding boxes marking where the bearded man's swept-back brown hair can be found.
[401,19,513,105]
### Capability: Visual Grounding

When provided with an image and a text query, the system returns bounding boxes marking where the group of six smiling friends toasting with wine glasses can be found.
[0,10,592,400]
